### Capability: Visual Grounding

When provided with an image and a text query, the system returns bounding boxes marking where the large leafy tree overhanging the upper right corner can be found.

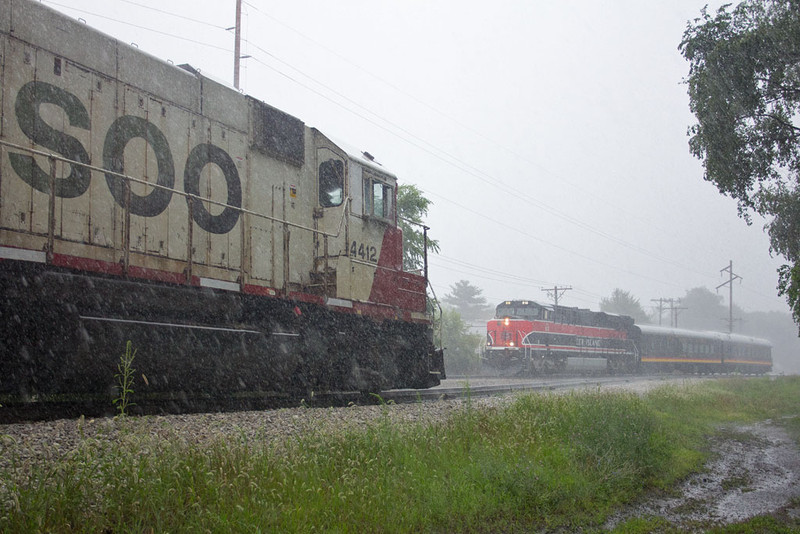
[680,0,800,330]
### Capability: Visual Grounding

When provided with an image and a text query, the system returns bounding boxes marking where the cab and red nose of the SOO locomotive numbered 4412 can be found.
[307,135,429,321]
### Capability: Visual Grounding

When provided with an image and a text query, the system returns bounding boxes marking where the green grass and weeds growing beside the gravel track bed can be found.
[0,377,800,532]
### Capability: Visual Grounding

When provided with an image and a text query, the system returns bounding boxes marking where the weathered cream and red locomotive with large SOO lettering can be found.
[0,0,444,410]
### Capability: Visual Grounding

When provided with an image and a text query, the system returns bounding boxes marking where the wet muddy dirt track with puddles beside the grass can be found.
[606,421,800,531]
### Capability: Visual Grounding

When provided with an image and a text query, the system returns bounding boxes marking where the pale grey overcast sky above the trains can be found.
[43,0,788,318]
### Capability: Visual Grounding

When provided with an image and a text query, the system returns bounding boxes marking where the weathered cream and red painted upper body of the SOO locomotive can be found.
[0,0,425,319]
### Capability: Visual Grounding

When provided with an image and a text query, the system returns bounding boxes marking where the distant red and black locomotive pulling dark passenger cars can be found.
[483,300,772,375]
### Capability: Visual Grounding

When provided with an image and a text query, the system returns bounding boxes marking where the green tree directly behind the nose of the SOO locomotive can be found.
[397,184,439,271]
